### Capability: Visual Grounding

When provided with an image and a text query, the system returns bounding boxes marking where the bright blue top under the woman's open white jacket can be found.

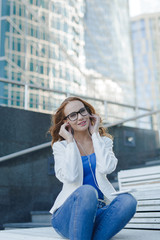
[81,153,104,199]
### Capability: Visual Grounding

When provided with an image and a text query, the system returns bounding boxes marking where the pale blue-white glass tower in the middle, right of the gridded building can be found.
[84,0,135,104]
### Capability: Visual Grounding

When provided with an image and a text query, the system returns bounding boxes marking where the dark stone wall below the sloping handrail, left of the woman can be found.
[0,148,61,227]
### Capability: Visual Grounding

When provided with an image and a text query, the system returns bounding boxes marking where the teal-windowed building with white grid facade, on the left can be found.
[0,0,85,111]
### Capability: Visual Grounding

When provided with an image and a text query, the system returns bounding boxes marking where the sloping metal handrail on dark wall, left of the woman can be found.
[0,142,51,162]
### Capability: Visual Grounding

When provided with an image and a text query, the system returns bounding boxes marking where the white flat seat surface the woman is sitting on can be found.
[0,227,160,240]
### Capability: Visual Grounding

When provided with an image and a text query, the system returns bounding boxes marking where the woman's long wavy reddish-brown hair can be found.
[49,97,112,145]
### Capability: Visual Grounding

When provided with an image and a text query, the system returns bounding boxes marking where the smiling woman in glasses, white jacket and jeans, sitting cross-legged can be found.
[50,97,136,240]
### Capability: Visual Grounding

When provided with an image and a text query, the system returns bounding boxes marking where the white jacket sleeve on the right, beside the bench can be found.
[92,133,118,174]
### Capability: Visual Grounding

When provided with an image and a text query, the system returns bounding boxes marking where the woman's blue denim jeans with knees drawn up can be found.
[52,185,137,240]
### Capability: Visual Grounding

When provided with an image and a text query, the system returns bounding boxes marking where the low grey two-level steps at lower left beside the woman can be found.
[3,211,51,230]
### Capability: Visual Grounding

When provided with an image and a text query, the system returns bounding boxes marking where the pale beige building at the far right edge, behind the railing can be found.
[131,13,160,127]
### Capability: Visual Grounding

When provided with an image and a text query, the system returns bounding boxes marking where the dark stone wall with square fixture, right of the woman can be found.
[110,126,160,172]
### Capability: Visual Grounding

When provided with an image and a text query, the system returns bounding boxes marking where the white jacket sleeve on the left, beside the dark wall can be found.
[53,142,78,183]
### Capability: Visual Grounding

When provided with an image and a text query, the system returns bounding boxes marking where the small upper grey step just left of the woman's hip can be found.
[30,211,52,224]
